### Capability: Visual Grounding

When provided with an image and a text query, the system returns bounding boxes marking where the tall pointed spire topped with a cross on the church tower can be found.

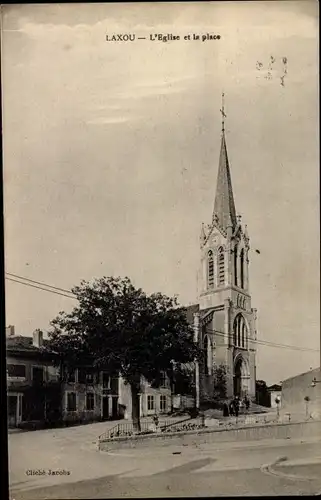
[213,94,236,230]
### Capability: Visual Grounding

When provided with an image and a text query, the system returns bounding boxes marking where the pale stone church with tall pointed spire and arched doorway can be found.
[187,98,257,406]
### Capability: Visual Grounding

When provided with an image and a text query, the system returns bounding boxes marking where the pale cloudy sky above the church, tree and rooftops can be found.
[1,1,320,384]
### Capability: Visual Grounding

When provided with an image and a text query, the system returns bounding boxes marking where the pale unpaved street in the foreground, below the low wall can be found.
[9,424,321,500]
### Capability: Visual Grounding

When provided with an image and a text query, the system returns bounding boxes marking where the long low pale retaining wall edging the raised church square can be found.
[98,421,321,451]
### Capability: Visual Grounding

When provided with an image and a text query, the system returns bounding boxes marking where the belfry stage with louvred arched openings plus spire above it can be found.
[199,94,250,309]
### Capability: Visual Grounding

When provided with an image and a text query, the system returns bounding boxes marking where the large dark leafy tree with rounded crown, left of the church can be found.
[44,277,201,431]
